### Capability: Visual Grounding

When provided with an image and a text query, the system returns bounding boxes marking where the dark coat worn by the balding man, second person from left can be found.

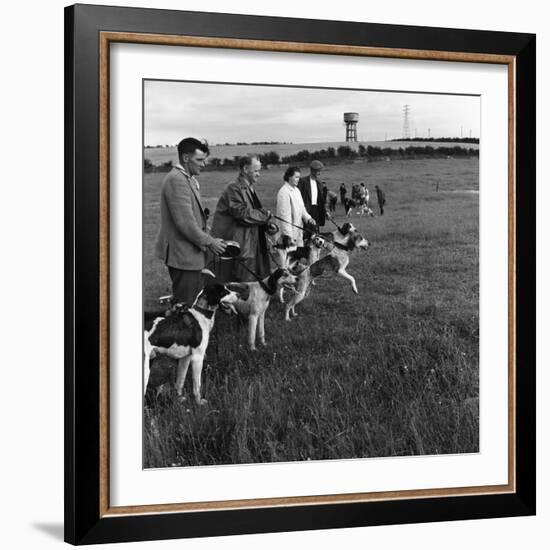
[212,174,269,258]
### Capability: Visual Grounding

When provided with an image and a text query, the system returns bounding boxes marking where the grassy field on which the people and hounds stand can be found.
[144,159,479,467]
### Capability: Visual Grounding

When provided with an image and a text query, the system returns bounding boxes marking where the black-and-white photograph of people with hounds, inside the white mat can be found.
[142,79,481,469]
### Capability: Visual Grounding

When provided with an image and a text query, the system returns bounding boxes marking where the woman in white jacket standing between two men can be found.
[277,166,315,246]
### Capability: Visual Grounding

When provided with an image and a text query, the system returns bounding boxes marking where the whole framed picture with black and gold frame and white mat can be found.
[65,5,535,544]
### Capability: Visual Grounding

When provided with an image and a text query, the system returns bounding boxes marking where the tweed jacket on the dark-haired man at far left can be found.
[155,168,213,271]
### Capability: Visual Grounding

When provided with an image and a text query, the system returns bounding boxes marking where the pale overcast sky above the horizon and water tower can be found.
[144,81,480,145]
